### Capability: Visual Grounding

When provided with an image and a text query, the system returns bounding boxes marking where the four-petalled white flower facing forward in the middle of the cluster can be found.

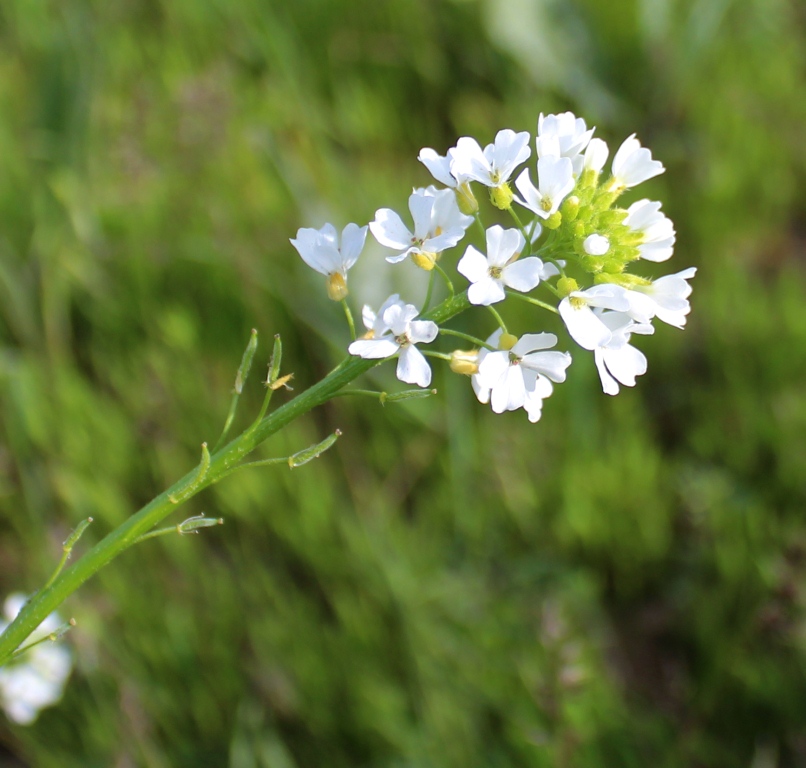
[456,224,544,306]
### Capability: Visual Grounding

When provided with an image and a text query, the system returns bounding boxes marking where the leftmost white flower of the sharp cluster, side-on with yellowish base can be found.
[291,223,367,301]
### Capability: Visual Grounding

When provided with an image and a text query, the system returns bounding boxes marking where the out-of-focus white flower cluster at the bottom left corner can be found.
[0,594,73,725]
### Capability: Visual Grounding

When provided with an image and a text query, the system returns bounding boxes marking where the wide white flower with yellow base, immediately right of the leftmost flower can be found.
[369,187,473,269]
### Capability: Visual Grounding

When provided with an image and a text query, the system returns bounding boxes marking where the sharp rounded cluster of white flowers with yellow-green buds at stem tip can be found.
[291,112,696,421]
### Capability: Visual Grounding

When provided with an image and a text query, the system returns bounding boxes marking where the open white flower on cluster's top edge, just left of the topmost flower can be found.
[449,128,532,187]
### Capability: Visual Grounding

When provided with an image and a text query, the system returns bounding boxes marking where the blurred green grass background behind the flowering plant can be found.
[0,0,806,768]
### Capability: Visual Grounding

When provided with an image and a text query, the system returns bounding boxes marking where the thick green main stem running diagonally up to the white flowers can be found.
[0,293,470,666]
